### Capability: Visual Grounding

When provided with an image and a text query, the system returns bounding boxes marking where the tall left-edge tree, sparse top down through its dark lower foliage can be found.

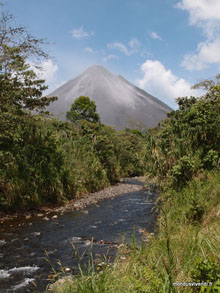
[0,5,56,170]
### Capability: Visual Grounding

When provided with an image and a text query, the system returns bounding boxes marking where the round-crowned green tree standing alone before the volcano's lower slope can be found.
[66,96,100,124]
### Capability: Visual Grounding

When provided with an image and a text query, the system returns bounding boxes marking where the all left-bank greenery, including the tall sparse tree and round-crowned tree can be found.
[0,7,148,211]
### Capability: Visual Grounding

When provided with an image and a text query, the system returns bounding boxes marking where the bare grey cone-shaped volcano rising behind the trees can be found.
[47,65,172,129]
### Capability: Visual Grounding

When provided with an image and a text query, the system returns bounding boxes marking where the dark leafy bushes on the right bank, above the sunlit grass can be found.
[146,75,220,187]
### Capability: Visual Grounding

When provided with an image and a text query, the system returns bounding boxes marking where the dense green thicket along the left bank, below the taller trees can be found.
[0,104,148,209]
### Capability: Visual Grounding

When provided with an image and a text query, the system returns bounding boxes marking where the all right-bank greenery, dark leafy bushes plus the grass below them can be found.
[50,75,220,293]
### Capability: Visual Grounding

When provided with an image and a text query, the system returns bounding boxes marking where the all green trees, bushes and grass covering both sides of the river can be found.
[0,5,220,292]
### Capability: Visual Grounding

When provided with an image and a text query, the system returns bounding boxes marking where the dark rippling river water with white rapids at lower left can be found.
[0,180,157,293]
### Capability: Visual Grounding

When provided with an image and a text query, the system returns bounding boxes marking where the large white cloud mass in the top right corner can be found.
[176,0,220,70]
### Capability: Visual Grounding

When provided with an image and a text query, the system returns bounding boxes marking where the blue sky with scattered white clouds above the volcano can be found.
[1,0,220,109]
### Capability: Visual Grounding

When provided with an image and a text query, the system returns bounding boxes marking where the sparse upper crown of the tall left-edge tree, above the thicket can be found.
[0,5,56,114]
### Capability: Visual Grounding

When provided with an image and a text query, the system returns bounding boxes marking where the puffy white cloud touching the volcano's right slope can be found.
[137,60,200,105]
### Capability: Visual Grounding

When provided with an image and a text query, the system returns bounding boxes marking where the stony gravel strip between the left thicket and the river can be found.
[0,176,145,225]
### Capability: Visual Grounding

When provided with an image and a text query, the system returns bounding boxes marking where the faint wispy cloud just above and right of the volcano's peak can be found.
[107,38,140,56]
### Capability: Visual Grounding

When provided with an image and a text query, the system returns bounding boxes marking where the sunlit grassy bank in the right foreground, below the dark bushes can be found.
[50,171,220,293]
